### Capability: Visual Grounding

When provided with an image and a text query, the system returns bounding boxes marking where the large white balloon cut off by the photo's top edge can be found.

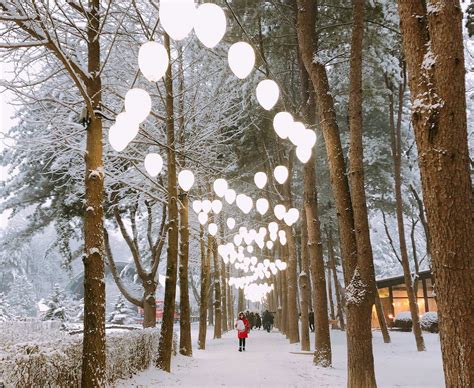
[159,0,196,40]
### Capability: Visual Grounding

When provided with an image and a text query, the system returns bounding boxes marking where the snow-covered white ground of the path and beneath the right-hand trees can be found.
[116,326,444,388]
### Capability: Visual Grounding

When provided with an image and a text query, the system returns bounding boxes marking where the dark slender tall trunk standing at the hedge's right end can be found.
[156,34,179,372]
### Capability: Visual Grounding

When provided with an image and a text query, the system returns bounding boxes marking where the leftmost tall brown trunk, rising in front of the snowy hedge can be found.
[81,0,106,387]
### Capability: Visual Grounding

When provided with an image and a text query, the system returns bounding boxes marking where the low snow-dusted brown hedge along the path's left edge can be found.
[0,322,177,387]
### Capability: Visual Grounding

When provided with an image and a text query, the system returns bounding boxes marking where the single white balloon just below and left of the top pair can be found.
[138,42,170,82]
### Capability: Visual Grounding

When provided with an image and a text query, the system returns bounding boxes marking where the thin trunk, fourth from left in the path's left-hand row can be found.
[198,225,211,350]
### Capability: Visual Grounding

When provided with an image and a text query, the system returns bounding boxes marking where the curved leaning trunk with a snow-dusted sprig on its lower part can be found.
[297,0,376,387]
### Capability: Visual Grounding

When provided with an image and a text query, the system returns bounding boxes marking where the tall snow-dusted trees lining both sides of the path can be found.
[0,0,473,387]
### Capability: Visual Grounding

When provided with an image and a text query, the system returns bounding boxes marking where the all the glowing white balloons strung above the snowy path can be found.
[109,0,316,301]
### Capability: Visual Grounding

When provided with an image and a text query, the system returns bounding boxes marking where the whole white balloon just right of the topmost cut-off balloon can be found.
[194,3,227,48]
